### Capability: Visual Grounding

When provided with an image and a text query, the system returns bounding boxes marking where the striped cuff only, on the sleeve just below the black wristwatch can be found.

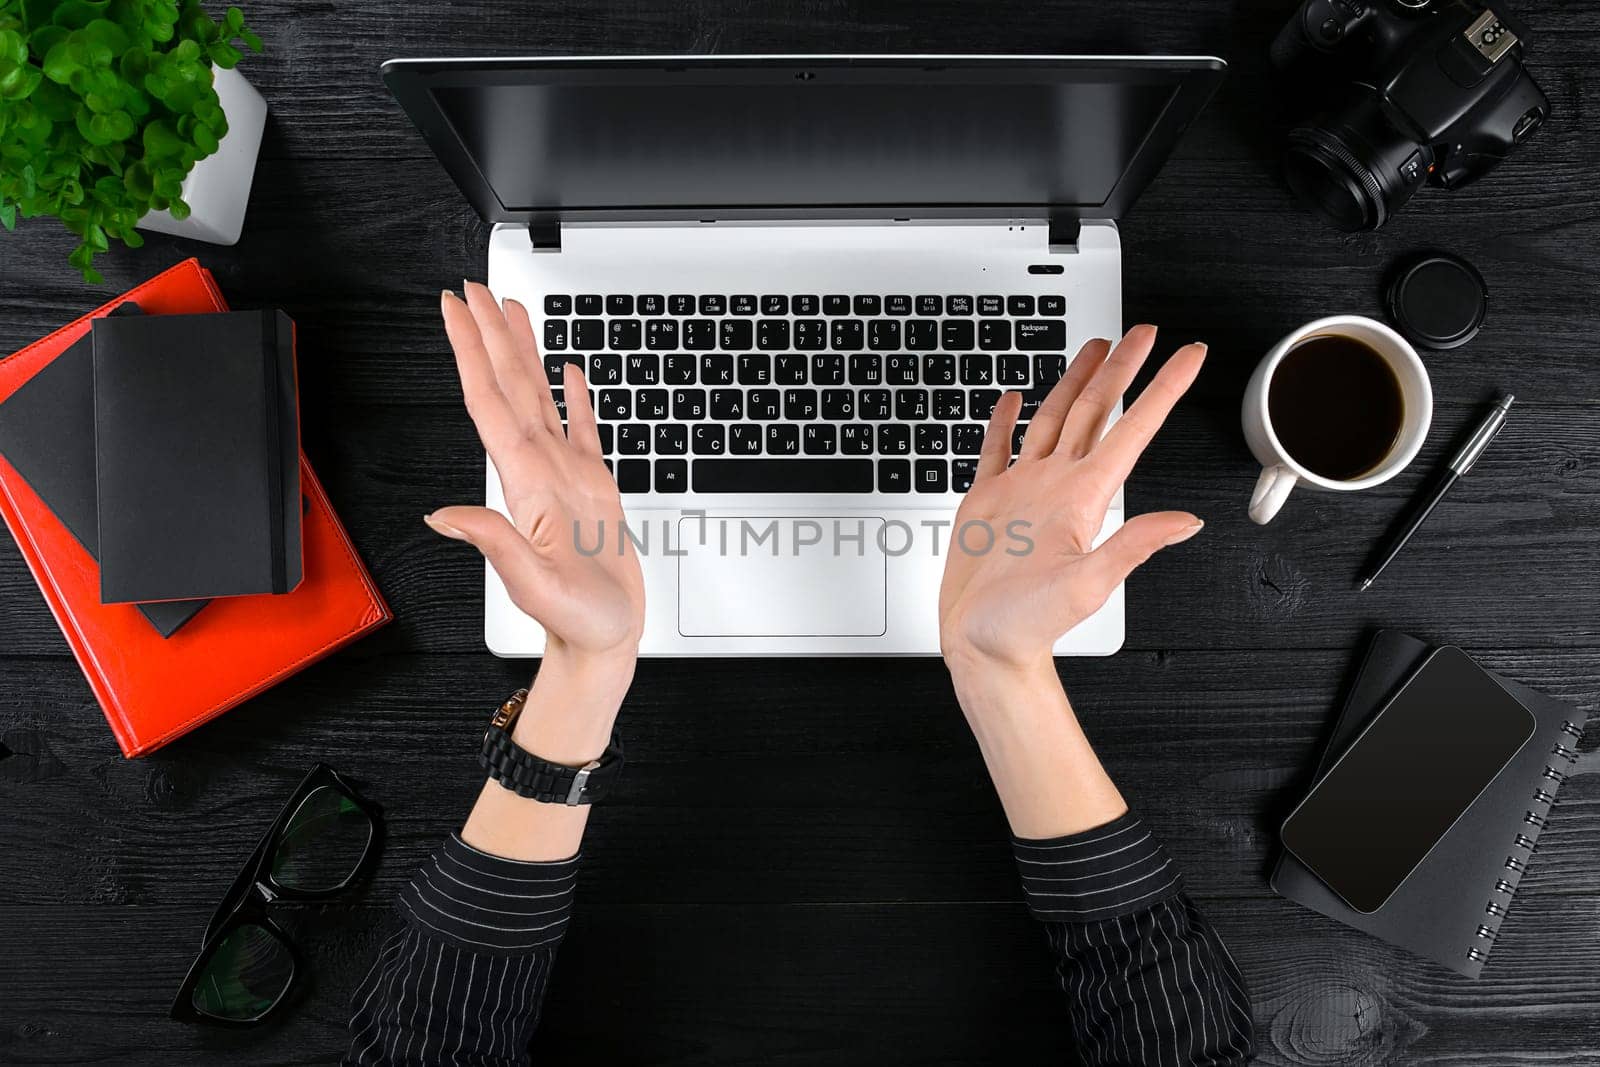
[400,833,578,955]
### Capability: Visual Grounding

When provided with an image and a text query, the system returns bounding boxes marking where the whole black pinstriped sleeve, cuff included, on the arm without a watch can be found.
[1013,813,1254,1067]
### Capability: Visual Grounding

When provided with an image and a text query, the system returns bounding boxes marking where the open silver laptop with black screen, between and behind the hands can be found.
[382,56,1224,656]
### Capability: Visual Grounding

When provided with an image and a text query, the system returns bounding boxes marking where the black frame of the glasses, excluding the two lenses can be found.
[171,763,384,1029]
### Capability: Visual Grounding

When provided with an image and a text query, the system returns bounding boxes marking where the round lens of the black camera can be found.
[1283,94,1426,232]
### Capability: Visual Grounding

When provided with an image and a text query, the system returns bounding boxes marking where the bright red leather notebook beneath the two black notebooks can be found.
[0,259,394,757]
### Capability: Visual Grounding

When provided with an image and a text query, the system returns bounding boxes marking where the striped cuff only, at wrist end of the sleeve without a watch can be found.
[1011,811,1184,923]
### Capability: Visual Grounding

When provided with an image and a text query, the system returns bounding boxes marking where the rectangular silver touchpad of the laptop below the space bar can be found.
[672,515,888,637]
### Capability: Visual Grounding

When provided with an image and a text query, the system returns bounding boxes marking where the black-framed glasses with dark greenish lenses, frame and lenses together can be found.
[171,763,382,1027]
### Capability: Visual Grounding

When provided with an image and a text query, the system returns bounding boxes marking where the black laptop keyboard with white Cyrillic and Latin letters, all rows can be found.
[541,293,1067,494]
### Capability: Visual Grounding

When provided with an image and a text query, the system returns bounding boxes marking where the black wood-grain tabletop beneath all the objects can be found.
[0,0,1600,1065]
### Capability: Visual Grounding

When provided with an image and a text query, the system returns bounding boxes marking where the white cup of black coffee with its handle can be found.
[1243,315,1434,525]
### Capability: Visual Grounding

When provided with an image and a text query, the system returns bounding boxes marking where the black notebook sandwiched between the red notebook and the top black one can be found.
[0,302,206,637]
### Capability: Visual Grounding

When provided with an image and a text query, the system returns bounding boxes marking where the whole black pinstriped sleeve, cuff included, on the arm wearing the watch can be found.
[344,835,578,1067]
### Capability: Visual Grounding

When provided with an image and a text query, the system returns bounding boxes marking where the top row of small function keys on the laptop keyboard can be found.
[544,293,1067,317]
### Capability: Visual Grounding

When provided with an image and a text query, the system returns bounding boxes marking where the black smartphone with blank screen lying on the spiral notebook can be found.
[1282,646,1534,913]
